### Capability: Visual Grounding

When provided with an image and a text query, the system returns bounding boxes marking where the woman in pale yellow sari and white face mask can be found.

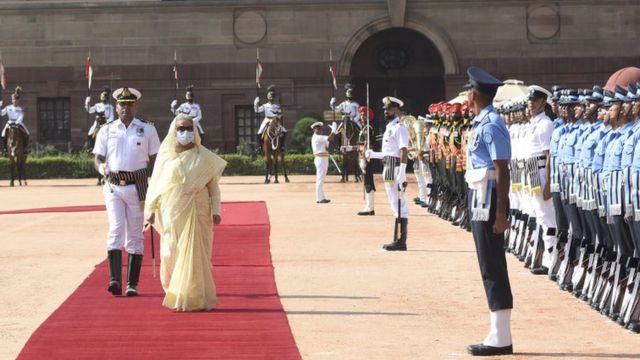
[144,114,227,311]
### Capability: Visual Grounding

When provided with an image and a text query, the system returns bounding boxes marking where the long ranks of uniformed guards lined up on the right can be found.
[416,76,640,353]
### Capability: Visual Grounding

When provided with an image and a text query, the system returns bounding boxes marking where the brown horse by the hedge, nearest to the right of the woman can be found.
[261,116,289,184]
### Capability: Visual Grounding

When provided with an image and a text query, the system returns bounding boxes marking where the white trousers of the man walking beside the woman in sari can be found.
[103,184,144,255]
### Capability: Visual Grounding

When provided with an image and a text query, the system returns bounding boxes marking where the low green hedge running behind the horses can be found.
[0,154,342,179]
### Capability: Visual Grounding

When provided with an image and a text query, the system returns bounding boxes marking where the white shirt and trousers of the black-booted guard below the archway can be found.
[382,117,409,219]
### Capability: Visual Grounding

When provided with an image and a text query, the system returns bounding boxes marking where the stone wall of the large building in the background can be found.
[0,0,640,151]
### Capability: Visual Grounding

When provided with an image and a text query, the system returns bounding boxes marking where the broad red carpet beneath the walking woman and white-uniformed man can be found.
[19,202,301,359]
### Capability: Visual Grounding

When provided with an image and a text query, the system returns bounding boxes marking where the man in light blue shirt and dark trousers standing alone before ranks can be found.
[465,67,513,356]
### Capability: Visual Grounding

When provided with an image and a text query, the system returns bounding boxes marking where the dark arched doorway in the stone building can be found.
[349,28,445,126]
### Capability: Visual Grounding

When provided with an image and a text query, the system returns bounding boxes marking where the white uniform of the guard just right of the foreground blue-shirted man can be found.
[523,112,557,269]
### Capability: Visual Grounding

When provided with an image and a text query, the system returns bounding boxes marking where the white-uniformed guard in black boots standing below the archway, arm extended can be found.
[365,96,409,251]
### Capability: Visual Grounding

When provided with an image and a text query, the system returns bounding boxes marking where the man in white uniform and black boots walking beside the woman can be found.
[93,87,160,296]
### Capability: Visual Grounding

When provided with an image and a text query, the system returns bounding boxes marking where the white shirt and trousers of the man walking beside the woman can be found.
[93,118,160,255]
